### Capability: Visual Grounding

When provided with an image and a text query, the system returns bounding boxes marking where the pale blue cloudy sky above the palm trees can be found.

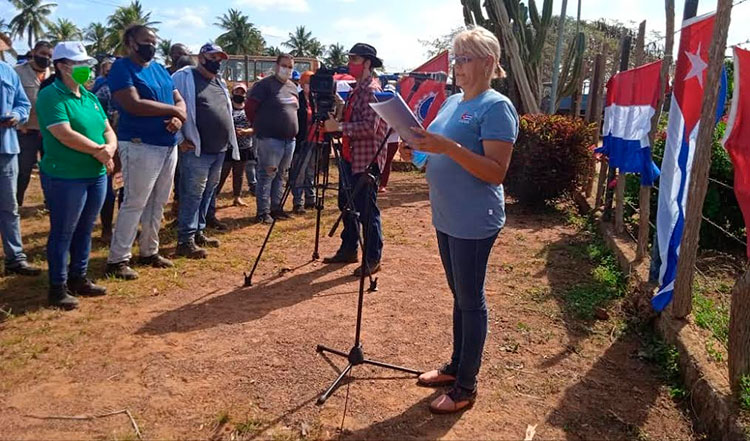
[0,0,750,71]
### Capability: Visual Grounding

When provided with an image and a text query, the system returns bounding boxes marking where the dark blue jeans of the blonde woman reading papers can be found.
[437,231,498,390]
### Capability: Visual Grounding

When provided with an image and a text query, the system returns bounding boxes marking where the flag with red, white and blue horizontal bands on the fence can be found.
[596,61,662,186]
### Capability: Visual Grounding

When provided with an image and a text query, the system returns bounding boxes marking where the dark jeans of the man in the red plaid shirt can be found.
[338,160,383,265]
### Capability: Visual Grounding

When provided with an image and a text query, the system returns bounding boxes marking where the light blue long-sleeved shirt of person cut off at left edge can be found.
[0,61,31,155]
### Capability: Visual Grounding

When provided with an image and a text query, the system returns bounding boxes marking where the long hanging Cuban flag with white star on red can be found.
[651,13,727,311]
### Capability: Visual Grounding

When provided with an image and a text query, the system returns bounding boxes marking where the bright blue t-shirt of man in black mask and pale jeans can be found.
[107,57,177,147]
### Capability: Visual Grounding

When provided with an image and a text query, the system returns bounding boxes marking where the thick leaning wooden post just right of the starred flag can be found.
[672,0,732,318]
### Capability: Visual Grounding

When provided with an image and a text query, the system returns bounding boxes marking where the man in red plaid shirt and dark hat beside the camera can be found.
[323,43,387,276]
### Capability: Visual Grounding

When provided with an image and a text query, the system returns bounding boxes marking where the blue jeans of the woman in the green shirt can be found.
[41,173,107,286]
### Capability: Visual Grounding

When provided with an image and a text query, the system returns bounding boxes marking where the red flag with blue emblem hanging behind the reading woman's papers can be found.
[399,51,450,127]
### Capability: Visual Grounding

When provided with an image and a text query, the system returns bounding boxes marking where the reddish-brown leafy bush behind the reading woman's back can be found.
[505,115,595,205]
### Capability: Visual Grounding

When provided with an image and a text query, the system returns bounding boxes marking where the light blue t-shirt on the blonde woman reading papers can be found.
[427,89,518,240]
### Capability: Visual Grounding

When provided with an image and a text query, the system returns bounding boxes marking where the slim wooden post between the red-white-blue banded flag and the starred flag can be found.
[635,0,674,261]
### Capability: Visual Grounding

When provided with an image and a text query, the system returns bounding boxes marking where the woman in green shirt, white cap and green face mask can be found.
[37,41,117,309]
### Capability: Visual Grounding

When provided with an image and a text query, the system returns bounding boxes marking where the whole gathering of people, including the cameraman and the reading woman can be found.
[0,25,518,413]
